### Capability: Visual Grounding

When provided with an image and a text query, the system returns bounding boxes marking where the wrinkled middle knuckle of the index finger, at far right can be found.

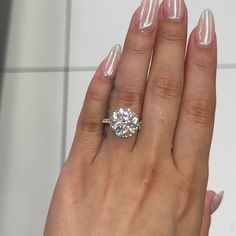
[185,99,215,124]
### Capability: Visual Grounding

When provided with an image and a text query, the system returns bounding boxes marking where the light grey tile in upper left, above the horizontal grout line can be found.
[3,0,67,68]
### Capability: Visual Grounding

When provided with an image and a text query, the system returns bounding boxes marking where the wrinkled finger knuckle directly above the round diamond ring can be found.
[113,85,143,106]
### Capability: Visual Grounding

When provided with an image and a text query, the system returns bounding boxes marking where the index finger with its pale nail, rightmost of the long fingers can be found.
[173,10,217,175]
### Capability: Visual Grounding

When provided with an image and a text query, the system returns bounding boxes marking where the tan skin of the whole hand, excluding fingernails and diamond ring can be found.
[44,2,217,236]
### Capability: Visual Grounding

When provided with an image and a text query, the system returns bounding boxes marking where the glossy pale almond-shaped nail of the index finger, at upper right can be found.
[196,9,215,47]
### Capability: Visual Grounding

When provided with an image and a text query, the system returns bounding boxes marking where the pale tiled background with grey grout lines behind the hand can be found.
[0,0,236,236]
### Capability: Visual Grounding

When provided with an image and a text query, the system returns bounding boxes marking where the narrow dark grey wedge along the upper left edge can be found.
[0,0,12,112]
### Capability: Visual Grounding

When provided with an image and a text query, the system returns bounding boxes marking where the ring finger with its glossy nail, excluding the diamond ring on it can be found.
[104,0,158,150]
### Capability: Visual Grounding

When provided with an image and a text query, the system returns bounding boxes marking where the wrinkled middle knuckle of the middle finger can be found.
[150,72,182,100]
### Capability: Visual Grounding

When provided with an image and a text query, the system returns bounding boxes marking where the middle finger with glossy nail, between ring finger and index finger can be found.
[137,0,187,153]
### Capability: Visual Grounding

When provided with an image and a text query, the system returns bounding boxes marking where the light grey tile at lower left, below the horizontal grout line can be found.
[0,73,63,236]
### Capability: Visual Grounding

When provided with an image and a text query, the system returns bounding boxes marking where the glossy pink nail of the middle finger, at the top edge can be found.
[163,0,184,21]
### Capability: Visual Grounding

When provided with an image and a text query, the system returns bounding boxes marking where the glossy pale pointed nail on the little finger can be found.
[103,44,122,78]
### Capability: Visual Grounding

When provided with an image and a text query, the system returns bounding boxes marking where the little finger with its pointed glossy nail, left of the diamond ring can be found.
[67,45,121,163]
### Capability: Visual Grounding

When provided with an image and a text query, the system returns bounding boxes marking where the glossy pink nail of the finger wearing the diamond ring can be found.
[137,0,159,31]
